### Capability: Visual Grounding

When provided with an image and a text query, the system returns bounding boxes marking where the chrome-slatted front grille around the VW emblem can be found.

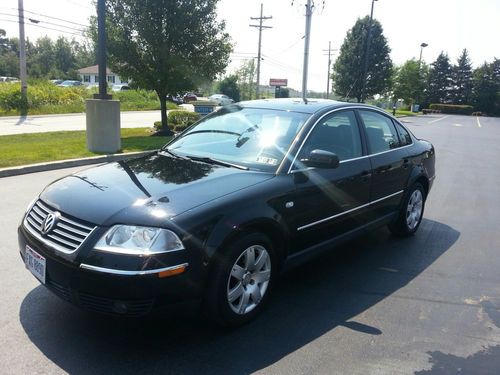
[24,200,95,254]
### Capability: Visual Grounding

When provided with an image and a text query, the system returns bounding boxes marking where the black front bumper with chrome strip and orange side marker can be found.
[18,225,202,317]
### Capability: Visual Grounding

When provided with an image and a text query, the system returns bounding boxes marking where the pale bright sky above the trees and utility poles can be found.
[0,0,500,92]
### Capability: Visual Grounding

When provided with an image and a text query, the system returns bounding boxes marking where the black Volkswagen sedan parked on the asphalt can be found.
[19,99,435,325]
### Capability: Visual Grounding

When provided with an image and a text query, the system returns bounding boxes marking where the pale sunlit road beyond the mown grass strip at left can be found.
[0,111,161,136]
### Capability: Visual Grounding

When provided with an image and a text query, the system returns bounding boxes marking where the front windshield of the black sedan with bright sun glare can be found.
[167,105,309,172]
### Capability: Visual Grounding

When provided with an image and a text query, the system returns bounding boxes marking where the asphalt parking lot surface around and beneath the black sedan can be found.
[0,115,500,375]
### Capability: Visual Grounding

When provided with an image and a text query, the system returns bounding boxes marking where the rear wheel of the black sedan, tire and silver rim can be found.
[389,182,426,237]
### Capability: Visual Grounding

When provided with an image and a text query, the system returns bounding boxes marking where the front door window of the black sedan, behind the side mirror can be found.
[296,111,362,169]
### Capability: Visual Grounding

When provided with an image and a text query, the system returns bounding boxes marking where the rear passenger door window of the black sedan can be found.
[359,110,399,154]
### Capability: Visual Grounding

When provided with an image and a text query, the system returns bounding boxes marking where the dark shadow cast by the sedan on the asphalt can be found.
[19,219,460,374]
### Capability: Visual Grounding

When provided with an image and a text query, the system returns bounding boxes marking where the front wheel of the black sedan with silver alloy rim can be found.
[203,233,277,327]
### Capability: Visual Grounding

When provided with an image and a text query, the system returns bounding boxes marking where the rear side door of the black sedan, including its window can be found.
[358,109,410,219]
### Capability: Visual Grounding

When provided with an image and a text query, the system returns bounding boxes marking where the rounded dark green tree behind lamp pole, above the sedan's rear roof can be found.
[332,16,392,102]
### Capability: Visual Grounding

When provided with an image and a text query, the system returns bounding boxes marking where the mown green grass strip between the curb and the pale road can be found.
[0,128,170,168]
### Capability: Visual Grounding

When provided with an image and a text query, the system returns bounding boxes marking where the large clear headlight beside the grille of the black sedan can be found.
[95,225,184,256]
